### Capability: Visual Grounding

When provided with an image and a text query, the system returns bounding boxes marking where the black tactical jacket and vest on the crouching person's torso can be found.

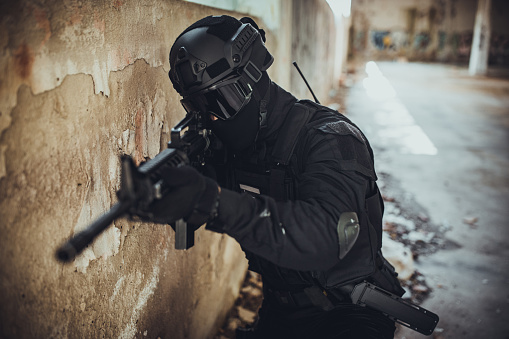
[207,83,383,290]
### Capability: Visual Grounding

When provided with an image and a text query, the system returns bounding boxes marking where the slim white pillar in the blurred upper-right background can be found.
[468,0,491,75]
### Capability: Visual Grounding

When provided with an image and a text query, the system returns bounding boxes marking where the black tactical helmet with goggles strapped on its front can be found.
[169,15,274,120]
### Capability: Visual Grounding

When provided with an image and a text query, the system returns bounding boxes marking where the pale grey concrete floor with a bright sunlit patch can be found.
[345,62,509,339]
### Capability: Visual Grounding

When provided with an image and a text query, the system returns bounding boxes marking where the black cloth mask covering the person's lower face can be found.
[210,98,260,151]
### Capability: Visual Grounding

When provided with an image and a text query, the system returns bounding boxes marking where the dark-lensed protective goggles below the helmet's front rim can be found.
[180,75,253,120]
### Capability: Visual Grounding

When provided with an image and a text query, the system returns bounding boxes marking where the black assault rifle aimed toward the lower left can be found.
[56,112,210,262]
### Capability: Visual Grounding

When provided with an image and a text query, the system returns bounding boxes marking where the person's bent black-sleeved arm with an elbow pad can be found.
[207,133,374,270]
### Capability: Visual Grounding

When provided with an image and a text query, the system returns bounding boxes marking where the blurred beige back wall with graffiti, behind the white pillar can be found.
[350,0,509,65]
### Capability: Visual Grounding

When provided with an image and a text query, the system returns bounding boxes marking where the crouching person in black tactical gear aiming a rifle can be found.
[157,15,403,339]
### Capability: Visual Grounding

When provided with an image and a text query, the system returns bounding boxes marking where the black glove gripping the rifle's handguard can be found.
[145,166,219,229]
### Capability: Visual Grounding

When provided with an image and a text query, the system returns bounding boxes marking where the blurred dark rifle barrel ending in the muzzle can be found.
[56,202,131,262]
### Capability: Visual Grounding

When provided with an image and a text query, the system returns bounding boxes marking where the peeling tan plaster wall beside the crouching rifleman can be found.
[0,0,342,338]
